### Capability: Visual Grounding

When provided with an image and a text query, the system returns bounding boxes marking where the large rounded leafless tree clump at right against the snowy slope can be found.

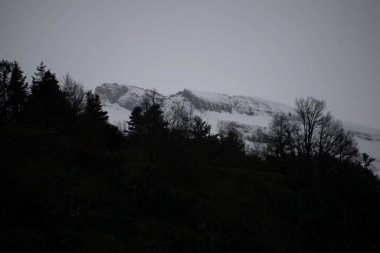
[268,97,358,160]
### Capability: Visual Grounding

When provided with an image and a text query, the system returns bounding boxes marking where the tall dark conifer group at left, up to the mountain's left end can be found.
[0,60,121,145]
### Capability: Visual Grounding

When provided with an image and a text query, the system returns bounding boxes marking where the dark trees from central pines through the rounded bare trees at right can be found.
[125,91,374,171]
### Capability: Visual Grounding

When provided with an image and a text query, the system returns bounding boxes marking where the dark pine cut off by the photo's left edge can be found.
[0,60,11,123]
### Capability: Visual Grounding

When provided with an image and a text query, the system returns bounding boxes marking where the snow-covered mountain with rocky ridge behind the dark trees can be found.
[95,83,380,176]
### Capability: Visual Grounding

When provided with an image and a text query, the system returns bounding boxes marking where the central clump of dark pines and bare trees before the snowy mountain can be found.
[126,91,248,169]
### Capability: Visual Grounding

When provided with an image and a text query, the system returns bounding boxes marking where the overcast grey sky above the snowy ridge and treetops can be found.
[0,0,380,129]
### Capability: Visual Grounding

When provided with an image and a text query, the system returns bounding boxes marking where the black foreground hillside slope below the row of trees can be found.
[0,125,380,252]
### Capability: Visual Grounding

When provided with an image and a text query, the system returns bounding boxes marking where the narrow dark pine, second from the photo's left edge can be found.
[8,61,28,122]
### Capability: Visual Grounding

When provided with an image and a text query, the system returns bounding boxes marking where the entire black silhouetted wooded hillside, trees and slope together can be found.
[0,60,380,253]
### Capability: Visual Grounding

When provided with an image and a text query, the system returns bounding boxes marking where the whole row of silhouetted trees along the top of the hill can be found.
[0,60,373,167]
